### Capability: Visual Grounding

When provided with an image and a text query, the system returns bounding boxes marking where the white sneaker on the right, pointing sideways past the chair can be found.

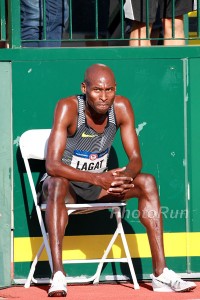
[150,268,196,292]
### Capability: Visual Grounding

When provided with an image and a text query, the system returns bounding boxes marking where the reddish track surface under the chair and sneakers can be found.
[0,282,200,300]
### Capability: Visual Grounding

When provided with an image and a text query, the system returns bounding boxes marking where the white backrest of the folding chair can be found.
[19,129,51,160]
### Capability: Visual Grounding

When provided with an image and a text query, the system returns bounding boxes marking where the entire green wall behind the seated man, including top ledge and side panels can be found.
[0,47,200,284]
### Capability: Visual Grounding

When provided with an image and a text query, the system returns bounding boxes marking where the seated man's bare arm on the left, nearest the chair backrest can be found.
[46,97,126,190]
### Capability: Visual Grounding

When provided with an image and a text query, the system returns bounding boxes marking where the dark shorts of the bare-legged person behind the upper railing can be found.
[124,0,194,24]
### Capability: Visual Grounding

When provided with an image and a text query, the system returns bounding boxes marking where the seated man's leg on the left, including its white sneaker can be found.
[41,177,75,297]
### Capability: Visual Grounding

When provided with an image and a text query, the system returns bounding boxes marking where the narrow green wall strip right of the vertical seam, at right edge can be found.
[188,58,200,272]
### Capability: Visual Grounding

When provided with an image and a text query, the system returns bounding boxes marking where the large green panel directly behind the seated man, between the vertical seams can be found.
[9,53,187,278]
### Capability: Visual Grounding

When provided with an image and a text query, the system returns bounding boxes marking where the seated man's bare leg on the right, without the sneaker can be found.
[99,174,166,276]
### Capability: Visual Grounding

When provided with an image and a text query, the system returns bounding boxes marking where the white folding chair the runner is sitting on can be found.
[19,129,140,289]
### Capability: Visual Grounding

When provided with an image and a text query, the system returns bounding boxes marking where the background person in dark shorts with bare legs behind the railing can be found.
[124,0,194,46]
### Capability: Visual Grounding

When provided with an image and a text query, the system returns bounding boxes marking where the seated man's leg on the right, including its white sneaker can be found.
[99,174,196,292]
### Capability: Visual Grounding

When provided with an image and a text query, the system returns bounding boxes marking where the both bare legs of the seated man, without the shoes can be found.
[43,174,166,276]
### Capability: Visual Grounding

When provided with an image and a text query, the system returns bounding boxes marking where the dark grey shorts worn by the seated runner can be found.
[38,173,102,203]
